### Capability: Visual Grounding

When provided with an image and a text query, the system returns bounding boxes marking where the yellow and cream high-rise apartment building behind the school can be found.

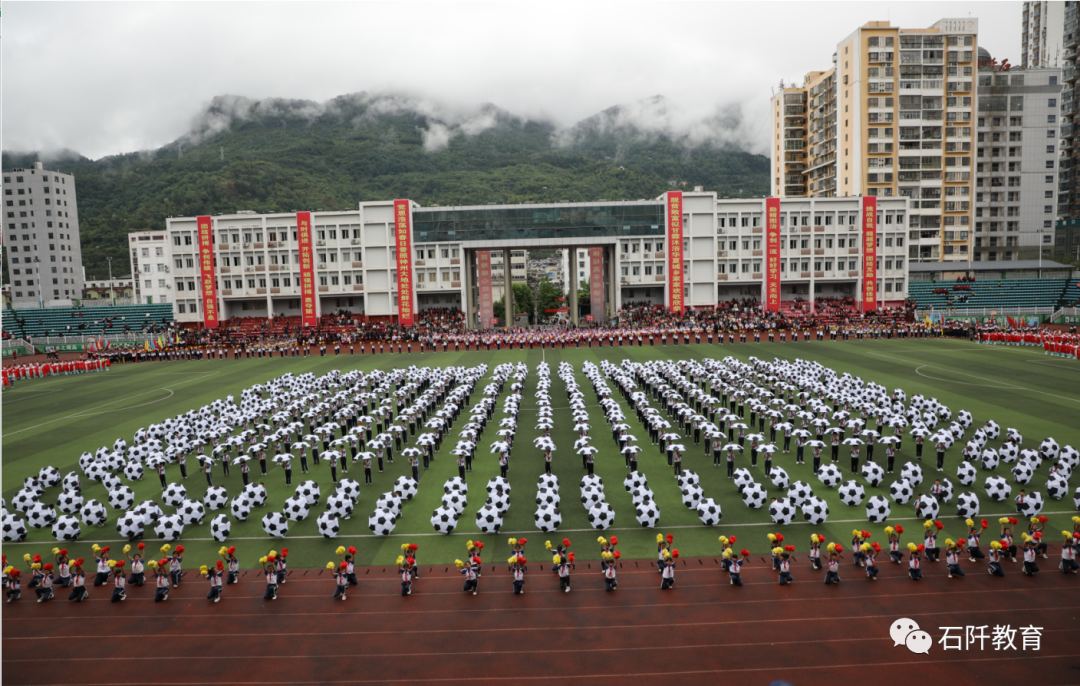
[771,18,978,261]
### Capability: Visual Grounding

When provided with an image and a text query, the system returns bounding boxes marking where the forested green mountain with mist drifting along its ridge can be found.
[3,93,769,282]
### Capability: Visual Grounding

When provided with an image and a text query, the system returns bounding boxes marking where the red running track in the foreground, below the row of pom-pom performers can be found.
[2,557,1080,686]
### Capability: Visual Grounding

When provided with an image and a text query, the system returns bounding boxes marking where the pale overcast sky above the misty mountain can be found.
[2,0,1022,159]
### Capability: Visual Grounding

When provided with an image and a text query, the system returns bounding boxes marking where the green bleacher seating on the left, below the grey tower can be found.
[3,304,173,338]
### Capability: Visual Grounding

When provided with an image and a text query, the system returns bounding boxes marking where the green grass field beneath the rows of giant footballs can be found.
[2,339,1080,568]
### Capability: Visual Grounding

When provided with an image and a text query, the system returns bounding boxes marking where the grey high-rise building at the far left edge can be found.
[3,162,83,309]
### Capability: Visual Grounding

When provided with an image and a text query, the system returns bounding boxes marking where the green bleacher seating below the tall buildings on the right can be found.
[907,279,1080,310]
